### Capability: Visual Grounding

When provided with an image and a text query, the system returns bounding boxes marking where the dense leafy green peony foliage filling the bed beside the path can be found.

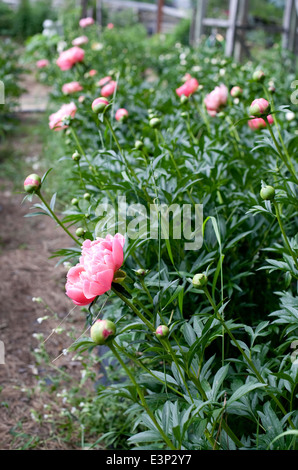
[23,19,298,450]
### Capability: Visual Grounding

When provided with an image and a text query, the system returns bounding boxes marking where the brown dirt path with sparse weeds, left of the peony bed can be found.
[0,87,93,450]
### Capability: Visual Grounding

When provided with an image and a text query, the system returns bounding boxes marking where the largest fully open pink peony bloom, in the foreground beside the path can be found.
[65,233,125,305]
